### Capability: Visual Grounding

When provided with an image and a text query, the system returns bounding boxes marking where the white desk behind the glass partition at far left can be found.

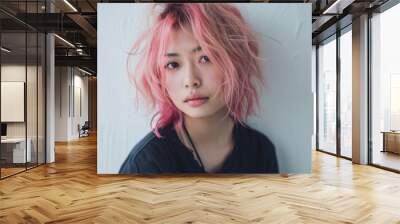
[1,138,32,163]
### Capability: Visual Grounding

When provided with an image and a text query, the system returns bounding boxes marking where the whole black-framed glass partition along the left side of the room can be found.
[0,1,46,179]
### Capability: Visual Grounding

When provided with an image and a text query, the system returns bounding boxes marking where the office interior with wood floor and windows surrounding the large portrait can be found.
[0,0,400,223]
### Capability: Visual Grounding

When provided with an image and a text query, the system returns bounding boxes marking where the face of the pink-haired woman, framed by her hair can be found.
[163,30,226,118]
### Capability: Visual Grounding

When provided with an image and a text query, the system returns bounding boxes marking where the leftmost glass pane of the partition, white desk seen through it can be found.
[0,29,27,177]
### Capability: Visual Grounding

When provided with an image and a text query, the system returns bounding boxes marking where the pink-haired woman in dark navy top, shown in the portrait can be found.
[119,3,278,174]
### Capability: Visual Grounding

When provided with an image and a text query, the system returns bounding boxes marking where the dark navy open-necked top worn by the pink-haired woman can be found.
[119,123,278,174]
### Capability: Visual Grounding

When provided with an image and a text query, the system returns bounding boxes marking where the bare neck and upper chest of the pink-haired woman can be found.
[184,110,234,150]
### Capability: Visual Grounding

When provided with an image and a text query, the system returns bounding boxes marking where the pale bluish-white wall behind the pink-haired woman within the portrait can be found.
[97,3,313,174]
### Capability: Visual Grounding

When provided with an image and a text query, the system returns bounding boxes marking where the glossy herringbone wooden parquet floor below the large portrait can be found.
[0,134,400,224]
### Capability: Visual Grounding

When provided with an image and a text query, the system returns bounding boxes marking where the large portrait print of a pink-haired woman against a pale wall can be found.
[97,3,313,174]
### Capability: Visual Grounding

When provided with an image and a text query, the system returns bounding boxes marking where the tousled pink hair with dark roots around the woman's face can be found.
[128,3,263,137]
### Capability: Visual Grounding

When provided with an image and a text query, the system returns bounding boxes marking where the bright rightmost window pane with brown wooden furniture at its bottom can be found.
[370,4,400,170]
